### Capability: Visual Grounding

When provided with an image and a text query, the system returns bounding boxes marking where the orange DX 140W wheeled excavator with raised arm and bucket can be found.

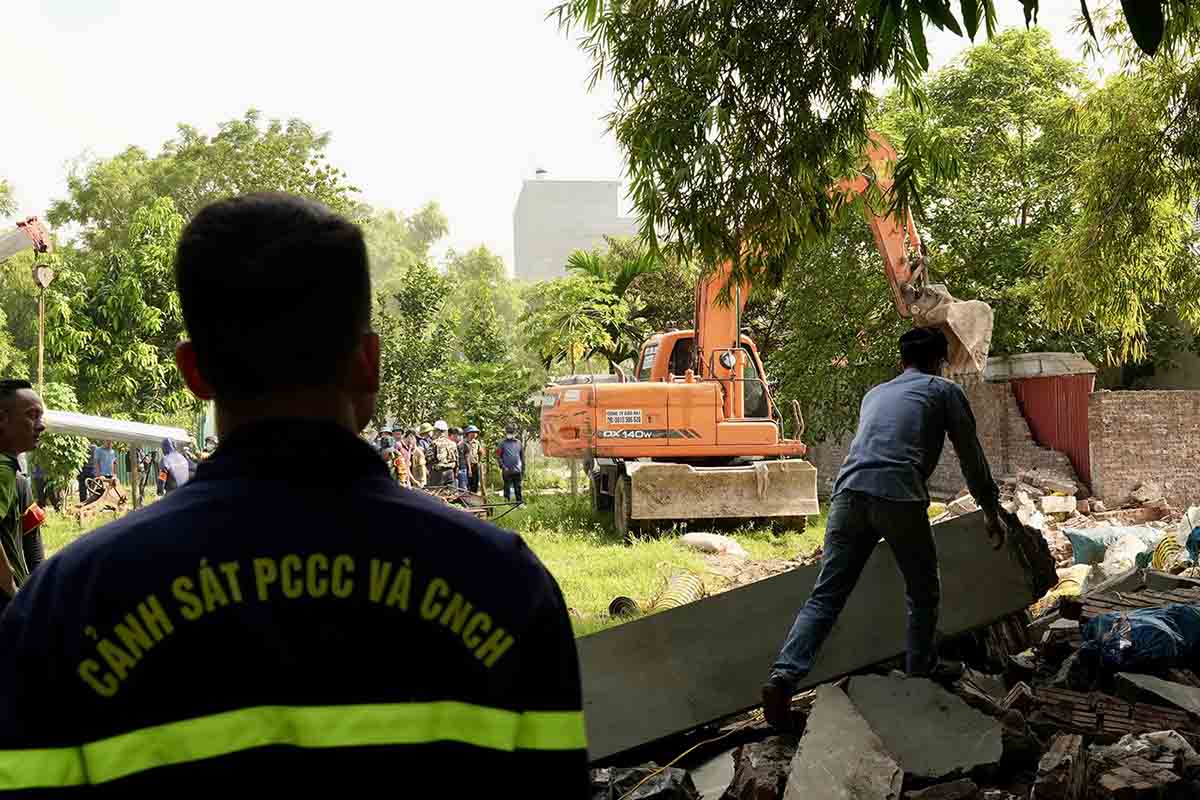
[541,134,992,536]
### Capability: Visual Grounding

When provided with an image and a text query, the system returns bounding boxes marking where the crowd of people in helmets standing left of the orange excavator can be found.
[374,420,526,503]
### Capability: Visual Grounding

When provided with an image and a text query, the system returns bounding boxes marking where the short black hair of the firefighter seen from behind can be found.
[175,193,371,397]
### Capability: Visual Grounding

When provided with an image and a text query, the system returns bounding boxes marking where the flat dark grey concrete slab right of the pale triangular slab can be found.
[850,675,1004,778]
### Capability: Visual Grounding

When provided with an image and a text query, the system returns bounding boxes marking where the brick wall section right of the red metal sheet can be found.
[1087,390,1200,509]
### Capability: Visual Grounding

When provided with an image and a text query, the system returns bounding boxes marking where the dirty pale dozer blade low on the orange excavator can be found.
[625,458,821,521]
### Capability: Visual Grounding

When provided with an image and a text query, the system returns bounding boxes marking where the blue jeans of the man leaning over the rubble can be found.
[772,492,942,684]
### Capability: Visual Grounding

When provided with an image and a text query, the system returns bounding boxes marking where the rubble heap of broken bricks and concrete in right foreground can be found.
[595,569,1200,800]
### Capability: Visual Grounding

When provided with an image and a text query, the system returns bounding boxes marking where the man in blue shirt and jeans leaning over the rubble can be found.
[762,327,1004,728]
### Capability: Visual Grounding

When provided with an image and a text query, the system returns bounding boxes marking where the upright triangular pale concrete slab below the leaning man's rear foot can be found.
[784,684,904,800]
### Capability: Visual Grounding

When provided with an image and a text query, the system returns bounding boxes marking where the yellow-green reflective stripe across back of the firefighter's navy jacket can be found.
[0,700,587,789]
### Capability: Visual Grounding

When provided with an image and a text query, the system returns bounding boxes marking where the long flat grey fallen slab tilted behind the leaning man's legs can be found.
[577,512,1056,760]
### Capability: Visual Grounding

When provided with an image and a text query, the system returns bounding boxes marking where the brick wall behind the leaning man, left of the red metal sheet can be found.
[808,375,1080,497]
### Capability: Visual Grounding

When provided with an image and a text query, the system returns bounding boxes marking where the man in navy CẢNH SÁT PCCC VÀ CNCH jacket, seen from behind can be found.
[0,194,588,798]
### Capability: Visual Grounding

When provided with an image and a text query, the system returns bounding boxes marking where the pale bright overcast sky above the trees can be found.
[0,0,1104,271]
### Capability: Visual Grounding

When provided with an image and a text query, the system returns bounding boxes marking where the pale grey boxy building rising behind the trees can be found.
[512,169,637,281]
